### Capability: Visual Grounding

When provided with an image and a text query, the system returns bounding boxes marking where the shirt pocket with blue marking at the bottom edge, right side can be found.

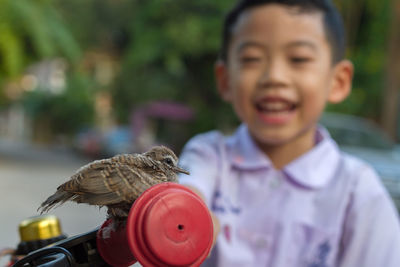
[292,223,337,267]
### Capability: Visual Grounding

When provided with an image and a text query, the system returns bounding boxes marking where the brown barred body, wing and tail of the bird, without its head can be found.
[39,154,167,212]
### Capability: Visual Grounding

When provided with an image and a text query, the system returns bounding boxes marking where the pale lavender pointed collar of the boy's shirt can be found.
[227,124,340,189]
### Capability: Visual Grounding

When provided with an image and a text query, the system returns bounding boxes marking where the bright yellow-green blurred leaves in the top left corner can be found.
[0,0,80,89]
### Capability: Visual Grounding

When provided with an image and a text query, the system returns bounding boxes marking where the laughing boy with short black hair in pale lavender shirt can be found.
[181,0,400,267]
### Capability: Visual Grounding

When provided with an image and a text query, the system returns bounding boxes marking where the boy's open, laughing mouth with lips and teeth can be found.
[255,98,298,124]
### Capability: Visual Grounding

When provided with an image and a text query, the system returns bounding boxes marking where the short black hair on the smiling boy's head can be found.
[219,0,346,63]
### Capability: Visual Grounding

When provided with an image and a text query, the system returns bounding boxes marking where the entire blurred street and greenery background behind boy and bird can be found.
[0,0,400,264]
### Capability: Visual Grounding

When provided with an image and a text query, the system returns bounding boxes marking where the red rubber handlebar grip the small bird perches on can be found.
[97,183,213,267]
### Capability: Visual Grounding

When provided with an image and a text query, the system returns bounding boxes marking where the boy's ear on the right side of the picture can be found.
[328,60,354,104]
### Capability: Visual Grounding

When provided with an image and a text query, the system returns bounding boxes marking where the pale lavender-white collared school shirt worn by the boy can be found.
[180,125,400,267]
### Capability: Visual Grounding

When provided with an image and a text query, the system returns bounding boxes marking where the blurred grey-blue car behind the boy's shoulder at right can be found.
[320,113,400,211]
